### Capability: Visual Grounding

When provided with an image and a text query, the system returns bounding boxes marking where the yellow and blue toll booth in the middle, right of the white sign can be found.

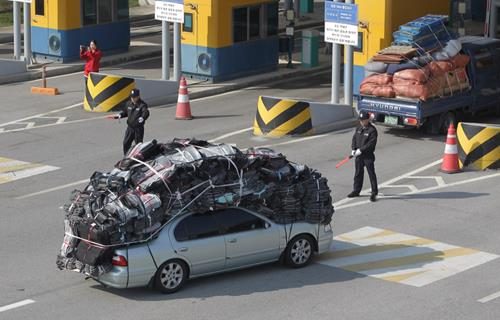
[182,0,279,82]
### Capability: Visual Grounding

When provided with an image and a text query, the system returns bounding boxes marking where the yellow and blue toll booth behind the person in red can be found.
[31,0,130,62]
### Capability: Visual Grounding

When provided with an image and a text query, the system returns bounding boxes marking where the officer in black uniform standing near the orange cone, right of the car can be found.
[347,111,378,202]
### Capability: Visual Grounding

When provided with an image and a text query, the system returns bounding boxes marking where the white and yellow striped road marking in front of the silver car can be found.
[318,227,498,287]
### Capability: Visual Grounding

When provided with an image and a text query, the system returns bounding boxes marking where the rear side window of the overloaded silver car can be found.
[174,213,220,242]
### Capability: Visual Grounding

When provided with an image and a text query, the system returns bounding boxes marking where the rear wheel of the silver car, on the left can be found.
[154,259,189,294]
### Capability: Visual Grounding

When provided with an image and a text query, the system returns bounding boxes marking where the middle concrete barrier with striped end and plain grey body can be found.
[253,96,356,137]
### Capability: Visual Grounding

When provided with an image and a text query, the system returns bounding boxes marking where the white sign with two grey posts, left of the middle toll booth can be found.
[155,0,184,81]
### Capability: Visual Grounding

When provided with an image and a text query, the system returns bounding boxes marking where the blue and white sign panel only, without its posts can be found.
[325,1,358,46]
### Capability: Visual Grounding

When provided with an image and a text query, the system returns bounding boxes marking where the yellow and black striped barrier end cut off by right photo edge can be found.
[457,122,500,170]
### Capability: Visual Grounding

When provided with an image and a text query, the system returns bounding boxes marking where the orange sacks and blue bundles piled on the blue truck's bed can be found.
[360,15,470,101]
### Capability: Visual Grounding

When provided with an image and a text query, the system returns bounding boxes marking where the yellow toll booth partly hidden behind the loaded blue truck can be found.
[353,0,450,94]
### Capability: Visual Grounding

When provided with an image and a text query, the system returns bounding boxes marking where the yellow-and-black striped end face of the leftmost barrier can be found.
[83,73,135,112]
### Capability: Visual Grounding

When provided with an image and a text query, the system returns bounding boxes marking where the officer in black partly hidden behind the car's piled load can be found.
[111,89,149,154]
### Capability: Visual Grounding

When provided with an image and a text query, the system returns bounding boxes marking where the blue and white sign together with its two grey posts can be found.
[325,0,358,105]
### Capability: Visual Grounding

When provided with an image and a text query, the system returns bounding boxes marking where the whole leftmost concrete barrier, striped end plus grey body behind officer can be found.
[83,73,179,112]
